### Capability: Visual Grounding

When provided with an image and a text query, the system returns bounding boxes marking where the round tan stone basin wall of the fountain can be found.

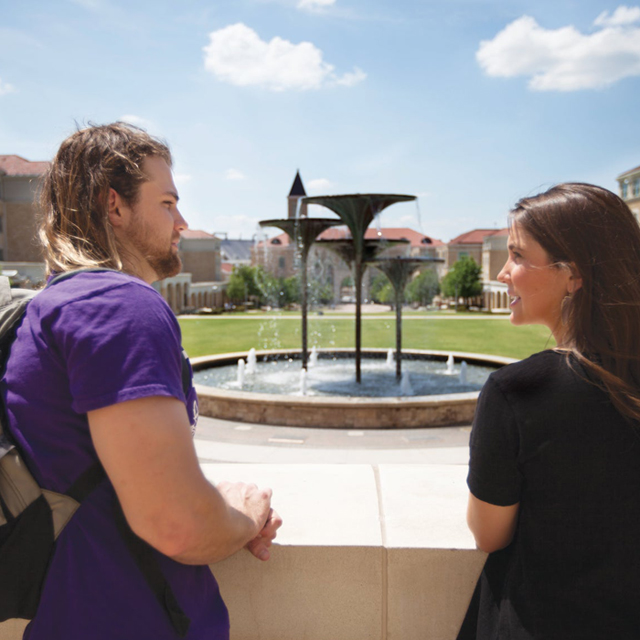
[191,349,515,429]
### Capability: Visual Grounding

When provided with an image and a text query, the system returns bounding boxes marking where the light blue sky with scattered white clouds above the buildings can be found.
[0,0,640,242]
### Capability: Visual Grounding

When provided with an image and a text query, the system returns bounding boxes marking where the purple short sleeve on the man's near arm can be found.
[51,282,185,413]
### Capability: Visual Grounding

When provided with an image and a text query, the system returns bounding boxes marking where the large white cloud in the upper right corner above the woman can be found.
[476,7,640,91]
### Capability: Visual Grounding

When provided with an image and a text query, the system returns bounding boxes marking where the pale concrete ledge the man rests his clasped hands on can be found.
[0,463,486,640]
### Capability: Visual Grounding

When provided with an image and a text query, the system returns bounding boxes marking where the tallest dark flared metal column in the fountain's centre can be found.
[302,193,416,382]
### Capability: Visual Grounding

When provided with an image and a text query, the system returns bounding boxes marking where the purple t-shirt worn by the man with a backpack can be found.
[0,272,229,640]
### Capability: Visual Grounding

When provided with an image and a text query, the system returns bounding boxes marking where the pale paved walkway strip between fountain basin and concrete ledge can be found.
[195,417,471,465]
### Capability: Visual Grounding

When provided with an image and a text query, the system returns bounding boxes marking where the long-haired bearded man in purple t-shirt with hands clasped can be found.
[1,123,281,640]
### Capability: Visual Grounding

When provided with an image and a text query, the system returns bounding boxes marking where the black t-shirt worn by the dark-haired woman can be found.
[467,351,640,640]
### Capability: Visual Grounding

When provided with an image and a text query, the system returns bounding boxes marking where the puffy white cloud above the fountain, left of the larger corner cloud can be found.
[204,23,366,91]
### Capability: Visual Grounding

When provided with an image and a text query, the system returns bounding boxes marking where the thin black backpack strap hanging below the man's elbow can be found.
[115,503,191,638]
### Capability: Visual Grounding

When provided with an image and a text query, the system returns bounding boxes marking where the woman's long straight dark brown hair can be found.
[509,183,640,420]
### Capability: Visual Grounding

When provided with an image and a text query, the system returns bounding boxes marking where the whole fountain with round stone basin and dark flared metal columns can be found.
[192,182,513,429]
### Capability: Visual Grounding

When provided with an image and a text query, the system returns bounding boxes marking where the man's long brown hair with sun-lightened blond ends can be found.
[38,122,171,273]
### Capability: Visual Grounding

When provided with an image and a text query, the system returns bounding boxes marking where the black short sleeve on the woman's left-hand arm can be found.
[467,376,522,507]
